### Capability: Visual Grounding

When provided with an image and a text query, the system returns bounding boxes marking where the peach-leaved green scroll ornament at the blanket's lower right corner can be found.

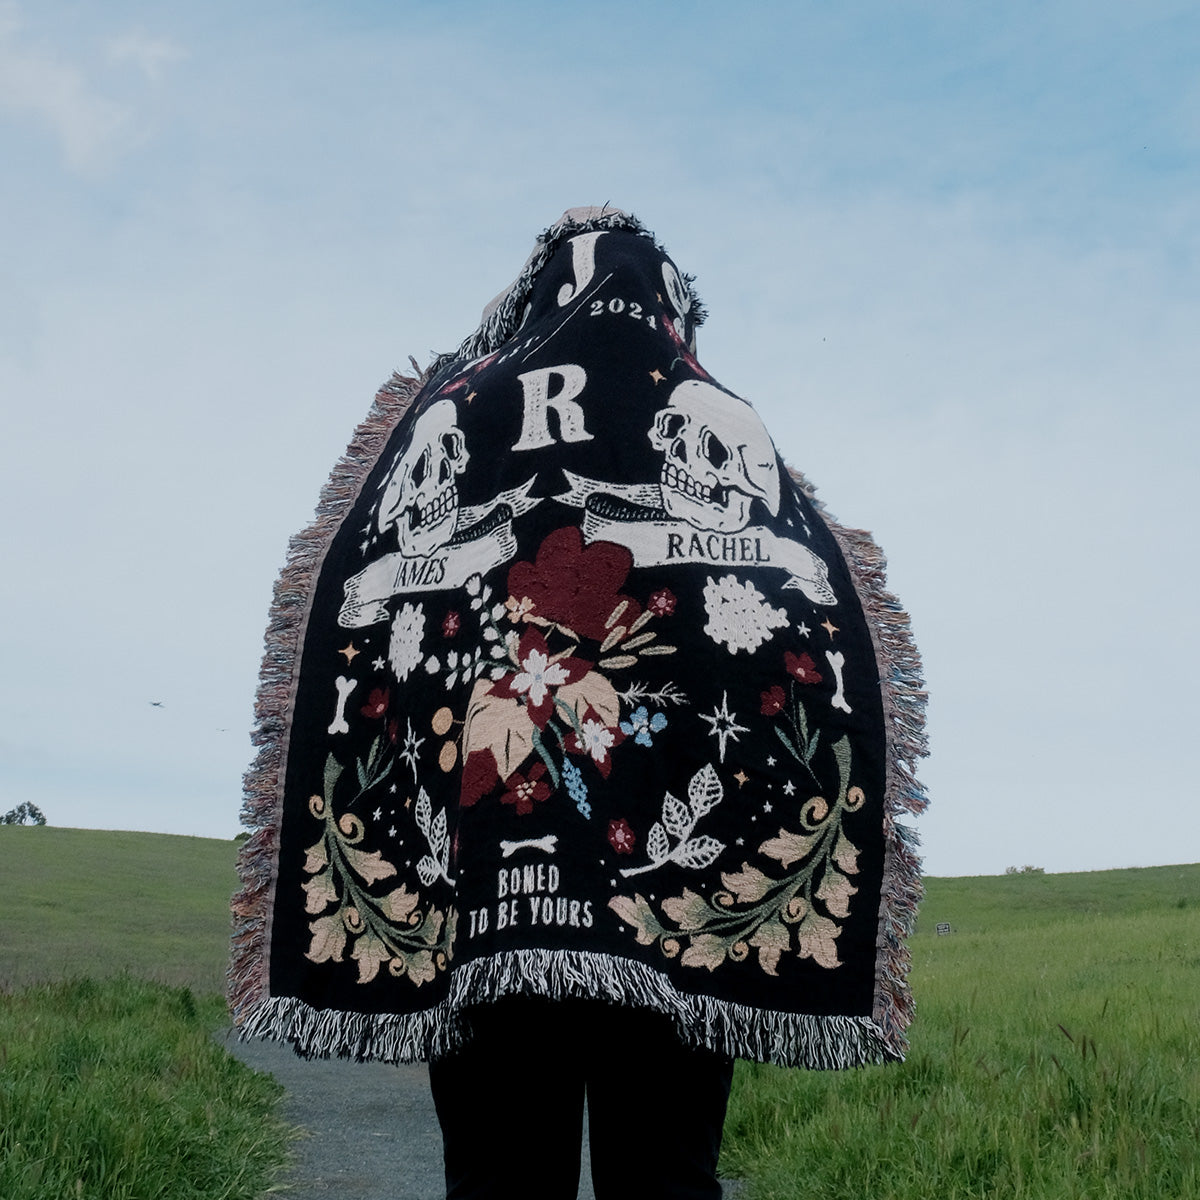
[608,736,865,976]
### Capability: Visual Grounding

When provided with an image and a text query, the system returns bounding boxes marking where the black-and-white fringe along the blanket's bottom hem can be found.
[241,949,895,1070]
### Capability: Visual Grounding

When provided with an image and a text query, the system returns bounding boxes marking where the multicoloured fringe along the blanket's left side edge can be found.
[227,362,428,1024]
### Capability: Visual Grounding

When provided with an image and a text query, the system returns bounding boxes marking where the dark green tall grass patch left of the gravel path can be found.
[0,977,290,1200]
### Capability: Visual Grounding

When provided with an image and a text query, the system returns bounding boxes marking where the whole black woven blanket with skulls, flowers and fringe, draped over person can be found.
[230,209,924,1067]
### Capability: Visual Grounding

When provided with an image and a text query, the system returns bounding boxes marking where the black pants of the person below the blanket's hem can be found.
[430,997,733,1200]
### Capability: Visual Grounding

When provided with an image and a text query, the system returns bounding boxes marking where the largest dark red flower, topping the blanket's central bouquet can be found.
[509,526,642,642]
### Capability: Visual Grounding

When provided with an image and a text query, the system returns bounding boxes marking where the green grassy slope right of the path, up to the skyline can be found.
[722,866,1200,1200]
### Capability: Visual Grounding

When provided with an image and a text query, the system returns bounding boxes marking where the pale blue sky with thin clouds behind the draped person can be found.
[0,0,1200,875]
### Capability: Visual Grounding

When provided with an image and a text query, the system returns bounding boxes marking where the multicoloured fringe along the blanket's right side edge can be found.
[788,468,929,1058]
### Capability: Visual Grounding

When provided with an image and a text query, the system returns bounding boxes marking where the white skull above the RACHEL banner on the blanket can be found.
[649,379,779,533]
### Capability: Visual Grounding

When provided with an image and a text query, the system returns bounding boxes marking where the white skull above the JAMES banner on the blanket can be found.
[377,400,469,558]
